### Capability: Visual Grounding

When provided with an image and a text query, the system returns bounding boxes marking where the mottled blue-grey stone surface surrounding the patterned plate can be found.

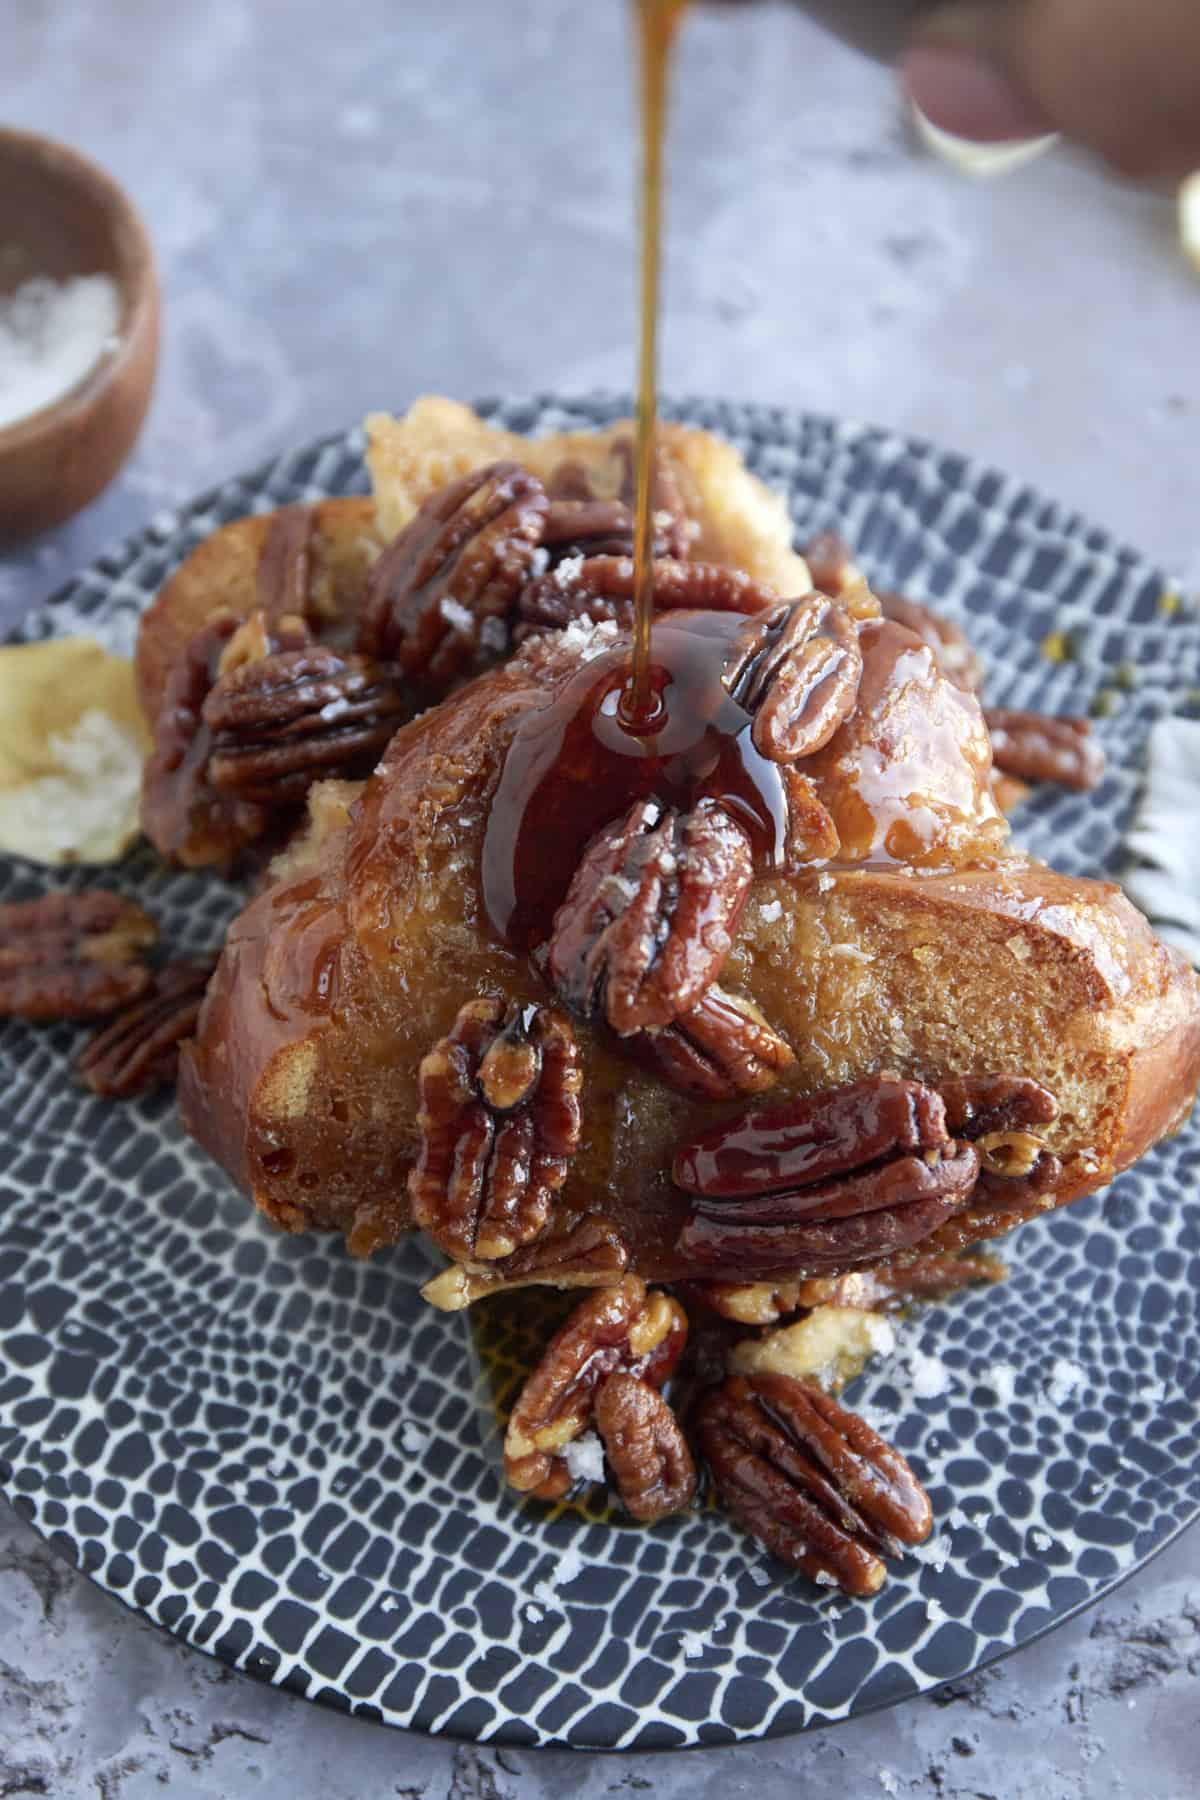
[0,0,1200,1800]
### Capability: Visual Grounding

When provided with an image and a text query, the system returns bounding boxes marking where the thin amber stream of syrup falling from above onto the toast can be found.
[621,0,687,736]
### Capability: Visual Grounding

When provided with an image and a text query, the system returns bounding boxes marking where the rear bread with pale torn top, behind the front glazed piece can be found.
[137,410,816,885]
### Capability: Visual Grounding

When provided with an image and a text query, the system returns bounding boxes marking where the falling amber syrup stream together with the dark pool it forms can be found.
[482,0,788,949]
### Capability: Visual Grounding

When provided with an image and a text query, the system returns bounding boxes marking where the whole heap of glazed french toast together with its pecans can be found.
[119,400,1200,1595]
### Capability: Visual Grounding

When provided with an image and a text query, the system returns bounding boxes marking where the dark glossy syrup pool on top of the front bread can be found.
[482,612,788,947]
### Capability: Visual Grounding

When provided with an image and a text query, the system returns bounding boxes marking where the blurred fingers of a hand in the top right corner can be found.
[900,0,1200,182]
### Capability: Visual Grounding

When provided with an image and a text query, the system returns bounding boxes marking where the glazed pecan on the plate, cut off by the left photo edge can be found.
[0,887,158,1022]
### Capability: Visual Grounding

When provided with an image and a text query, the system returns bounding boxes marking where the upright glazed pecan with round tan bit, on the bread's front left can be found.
[408,999,581,1262]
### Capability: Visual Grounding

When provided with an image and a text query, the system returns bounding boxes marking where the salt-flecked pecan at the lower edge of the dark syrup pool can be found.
[549,799,754,1037]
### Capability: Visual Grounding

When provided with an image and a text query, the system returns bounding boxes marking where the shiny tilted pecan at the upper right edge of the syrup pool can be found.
[725,594,862,763]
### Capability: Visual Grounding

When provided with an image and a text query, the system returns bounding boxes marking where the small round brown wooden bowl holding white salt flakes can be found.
[0,130,158,538]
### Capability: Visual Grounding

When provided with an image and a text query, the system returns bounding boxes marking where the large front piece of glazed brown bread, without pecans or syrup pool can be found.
[182,619,1200,1291]
